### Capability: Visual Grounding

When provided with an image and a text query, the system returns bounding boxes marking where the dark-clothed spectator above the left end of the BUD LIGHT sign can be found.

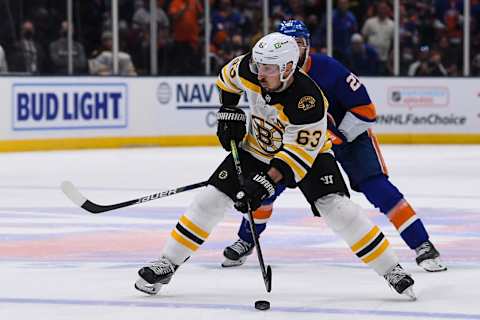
[8,20,46,74]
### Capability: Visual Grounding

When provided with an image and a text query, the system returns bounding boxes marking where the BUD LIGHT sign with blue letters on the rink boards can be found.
[12,83,128,130]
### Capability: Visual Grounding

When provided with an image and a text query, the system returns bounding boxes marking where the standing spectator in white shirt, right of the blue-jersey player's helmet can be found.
[362,1,394,75]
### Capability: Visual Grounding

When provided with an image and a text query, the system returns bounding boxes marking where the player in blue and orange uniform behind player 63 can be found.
[222,20,447,272]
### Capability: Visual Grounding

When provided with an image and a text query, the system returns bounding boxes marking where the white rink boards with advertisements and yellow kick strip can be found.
[0,77,480,151]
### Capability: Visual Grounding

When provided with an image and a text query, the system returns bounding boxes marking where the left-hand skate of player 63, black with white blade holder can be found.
[135,257,178,295]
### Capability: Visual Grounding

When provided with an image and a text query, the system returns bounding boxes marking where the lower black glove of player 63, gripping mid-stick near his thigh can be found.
[234,172,275,213]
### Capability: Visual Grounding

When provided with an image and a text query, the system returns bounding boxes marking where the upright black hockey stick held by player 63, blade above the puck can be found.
[230,140,272,292]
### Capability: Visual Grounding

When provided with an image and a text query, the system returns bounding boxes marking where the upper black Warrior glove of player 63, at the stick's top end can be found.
[217,106,247,151]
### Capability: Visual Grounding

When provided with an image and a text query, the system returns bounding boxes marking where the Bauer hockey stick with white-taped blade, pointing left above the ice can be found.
[61,181,208,213]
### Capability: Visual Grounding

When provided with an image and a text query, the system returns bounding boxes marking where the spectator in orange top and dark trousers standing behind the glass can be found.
[168,0,203,74]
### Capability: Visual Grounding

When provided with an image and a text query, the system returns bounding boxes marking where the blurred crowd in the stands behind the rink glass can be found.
[0,0,480,76]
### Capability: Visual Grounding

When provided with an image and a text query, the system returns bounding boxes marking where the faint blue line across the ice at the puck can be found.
[0,298,480,319]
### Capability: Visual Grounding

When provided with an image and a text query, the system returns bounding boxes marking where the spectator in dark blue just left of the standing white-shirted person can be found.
[348,33,379,76]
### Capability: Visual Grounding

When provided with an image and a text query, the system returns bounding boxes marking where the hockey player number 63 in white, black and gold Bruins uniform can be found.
[135,33,414,297]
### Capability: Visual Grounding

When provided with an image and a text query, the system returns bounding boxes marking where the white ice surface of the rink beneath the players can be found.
[0,146,480,320]
